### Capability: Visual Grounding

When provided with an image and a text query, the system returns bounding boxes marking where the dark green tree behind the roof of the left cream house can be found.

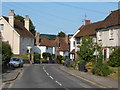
[15,15,36,36]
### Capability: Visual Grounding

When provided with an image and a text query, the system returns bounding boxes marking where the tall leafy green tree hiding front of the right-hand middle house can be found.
[77,36,95,61]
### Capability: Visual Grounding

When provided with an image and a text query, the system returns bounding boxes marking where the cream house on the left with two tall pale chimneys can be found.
[0,10,34,54]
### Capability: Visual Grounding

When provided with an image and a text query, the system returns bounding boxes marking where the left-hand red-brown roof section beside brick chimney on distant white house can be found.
[40,38,56,47]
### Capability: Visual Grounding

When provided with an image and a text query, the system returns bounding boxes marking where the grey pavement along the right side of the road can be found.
[60,65,120,88]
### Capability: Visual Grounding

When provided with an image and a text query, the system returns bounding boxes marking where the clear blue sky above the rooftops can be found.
[2,2,118,35]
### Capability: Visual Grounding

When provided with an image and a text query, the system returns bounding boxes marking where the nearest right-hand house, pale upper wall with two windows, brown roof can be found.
[96,9,120,60]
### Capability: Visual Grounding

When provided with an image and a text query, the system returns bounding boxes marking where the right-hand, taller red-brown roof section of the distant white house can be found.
[55,37,69,51]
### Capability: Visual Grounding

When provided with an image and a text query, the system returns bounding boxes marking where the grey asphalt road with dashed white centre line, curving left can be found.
[3,64,99,90]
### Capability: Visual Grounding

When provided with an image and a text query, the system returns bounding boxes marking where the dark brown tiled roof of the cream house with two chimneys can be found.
[3,16,34,38]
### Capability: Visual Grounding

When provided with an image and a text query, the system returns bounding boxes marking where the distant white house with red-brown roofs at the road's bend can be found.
[34,32,69,57]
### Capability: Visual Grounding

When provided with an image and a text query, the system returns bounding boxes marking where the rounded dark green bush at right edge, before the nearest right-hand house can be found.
[108,48,120,67]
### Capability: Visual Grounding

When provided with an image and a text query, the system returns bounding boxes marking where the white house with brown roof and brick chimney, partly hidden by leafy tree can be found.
[74,20,102,58]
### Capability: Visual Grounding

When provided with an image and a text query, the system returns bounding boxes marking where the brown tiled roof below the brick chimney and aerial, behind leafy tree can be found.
[75,21,102,37]
